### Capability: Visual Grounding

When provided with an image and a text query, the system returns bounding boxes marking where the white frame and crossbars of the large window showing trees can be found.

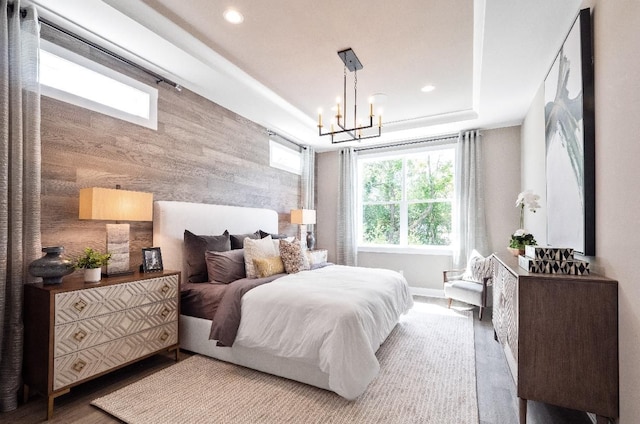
[356,144,458,255]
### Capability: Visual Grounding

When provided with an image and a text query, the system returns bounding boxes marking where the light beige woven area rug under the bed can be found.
[92,301,478,424]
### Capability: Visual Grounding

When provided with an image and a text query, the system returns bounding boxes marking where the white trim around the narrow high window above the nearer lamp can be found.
[40,40,158,130]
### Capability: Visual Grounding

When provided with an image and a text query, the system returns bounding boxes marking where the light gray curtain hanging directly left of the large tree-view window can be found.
[336,147,358,266]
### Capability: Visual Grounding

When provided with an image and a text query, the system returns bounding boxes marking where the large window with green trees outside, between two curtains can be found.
[358,146,455,252]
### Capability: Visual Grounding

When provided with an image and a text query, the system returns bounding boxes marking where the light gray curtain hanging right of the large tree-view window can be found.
[453,131,489,268]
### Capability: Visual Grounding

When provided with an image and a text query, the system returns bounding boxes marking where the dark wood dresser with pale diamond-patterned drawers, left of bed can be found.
[24,271,180,419]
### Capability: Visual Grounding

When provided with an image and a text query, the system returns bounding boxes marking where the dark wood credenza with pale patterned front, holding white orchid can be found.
[492,255,619,424]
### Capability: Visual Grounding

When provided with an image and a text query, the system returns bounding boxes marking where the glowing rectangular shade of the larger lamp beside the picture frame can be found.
[79,187,153,221]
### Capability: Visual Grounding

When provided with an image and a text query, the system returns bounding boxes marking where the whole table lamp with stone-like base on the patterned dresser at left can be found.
[78,187,153,276]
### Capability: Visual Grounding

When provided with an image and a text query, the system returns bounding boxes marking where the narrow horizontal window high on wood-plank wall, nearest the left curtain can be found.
[40,40,158,130]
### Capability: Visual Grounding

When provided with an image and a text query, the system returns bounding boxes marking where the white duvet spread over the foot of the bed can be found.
[234,265,413,399]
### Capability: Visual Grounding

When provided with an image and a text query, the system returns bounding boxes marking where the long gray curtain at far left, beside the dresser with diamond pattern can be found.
[0,0,41,412]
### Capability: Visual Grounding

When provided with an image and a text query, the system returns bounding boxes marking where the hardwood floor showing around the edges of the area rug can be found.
[0,302,591,424]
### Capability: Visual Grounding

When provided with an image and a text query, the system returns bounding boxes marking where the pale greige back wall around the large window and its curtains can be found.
[316,127,520,291]
